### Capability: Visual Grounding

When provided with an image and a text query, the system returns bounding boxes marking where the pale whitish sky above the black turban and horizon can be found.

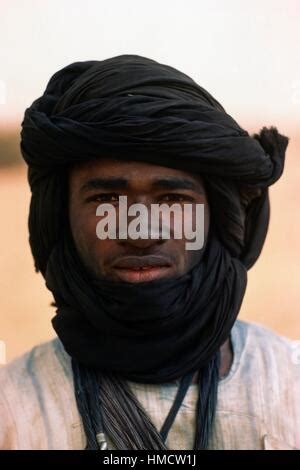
[0,0,300,130]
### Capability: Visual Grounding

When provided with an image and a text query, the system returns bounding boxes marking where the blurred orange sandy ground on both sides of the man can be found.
[0,140,300,360]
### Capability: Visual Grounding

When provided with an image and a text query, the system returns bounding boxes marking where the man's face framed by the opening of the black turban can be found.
[69,159,209,282]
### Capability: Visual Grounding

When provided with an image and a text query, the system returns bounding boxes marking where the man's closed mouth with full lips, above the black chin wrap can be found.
[113,256,172,282]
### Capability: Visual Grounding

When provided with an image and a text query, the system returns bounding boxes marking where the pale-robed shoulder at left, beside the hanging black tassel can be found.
[0,338,73,449]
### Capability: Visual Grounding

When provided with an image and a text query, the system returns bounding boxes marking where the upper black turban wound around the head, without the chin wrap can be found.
[21,55,288,273]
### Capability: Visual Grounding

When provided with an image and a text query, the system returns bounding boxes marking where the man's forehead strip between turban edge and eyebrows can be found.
[70,158,203,185]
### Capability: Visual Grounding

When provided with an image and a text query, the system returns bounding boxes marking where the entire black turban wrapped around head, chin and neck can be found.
[21,55,288,382]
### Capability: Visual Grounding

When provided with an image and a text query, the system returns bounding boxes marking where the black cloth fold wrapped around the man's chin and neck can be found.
[46,223,247,383]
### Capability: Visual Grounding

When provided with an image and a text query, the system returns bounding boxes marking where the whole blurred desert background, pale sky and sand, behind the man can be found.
[0,0,300,361]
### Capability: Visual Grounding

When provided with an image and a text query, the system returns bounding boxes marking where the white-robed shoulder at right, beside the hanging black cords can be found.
[219,320,300,449]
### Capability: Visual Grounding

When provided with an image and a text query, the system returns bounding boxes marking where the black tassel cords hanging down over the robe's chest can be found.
[72,353,220,450]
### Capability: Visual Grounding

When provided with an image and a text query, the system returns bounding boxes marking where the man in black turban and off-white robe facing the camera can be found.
[0,55,300,449]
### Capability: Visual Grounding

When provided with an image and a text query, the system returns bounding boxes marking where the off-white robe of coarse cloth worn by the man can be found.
[0,320,300,450]
